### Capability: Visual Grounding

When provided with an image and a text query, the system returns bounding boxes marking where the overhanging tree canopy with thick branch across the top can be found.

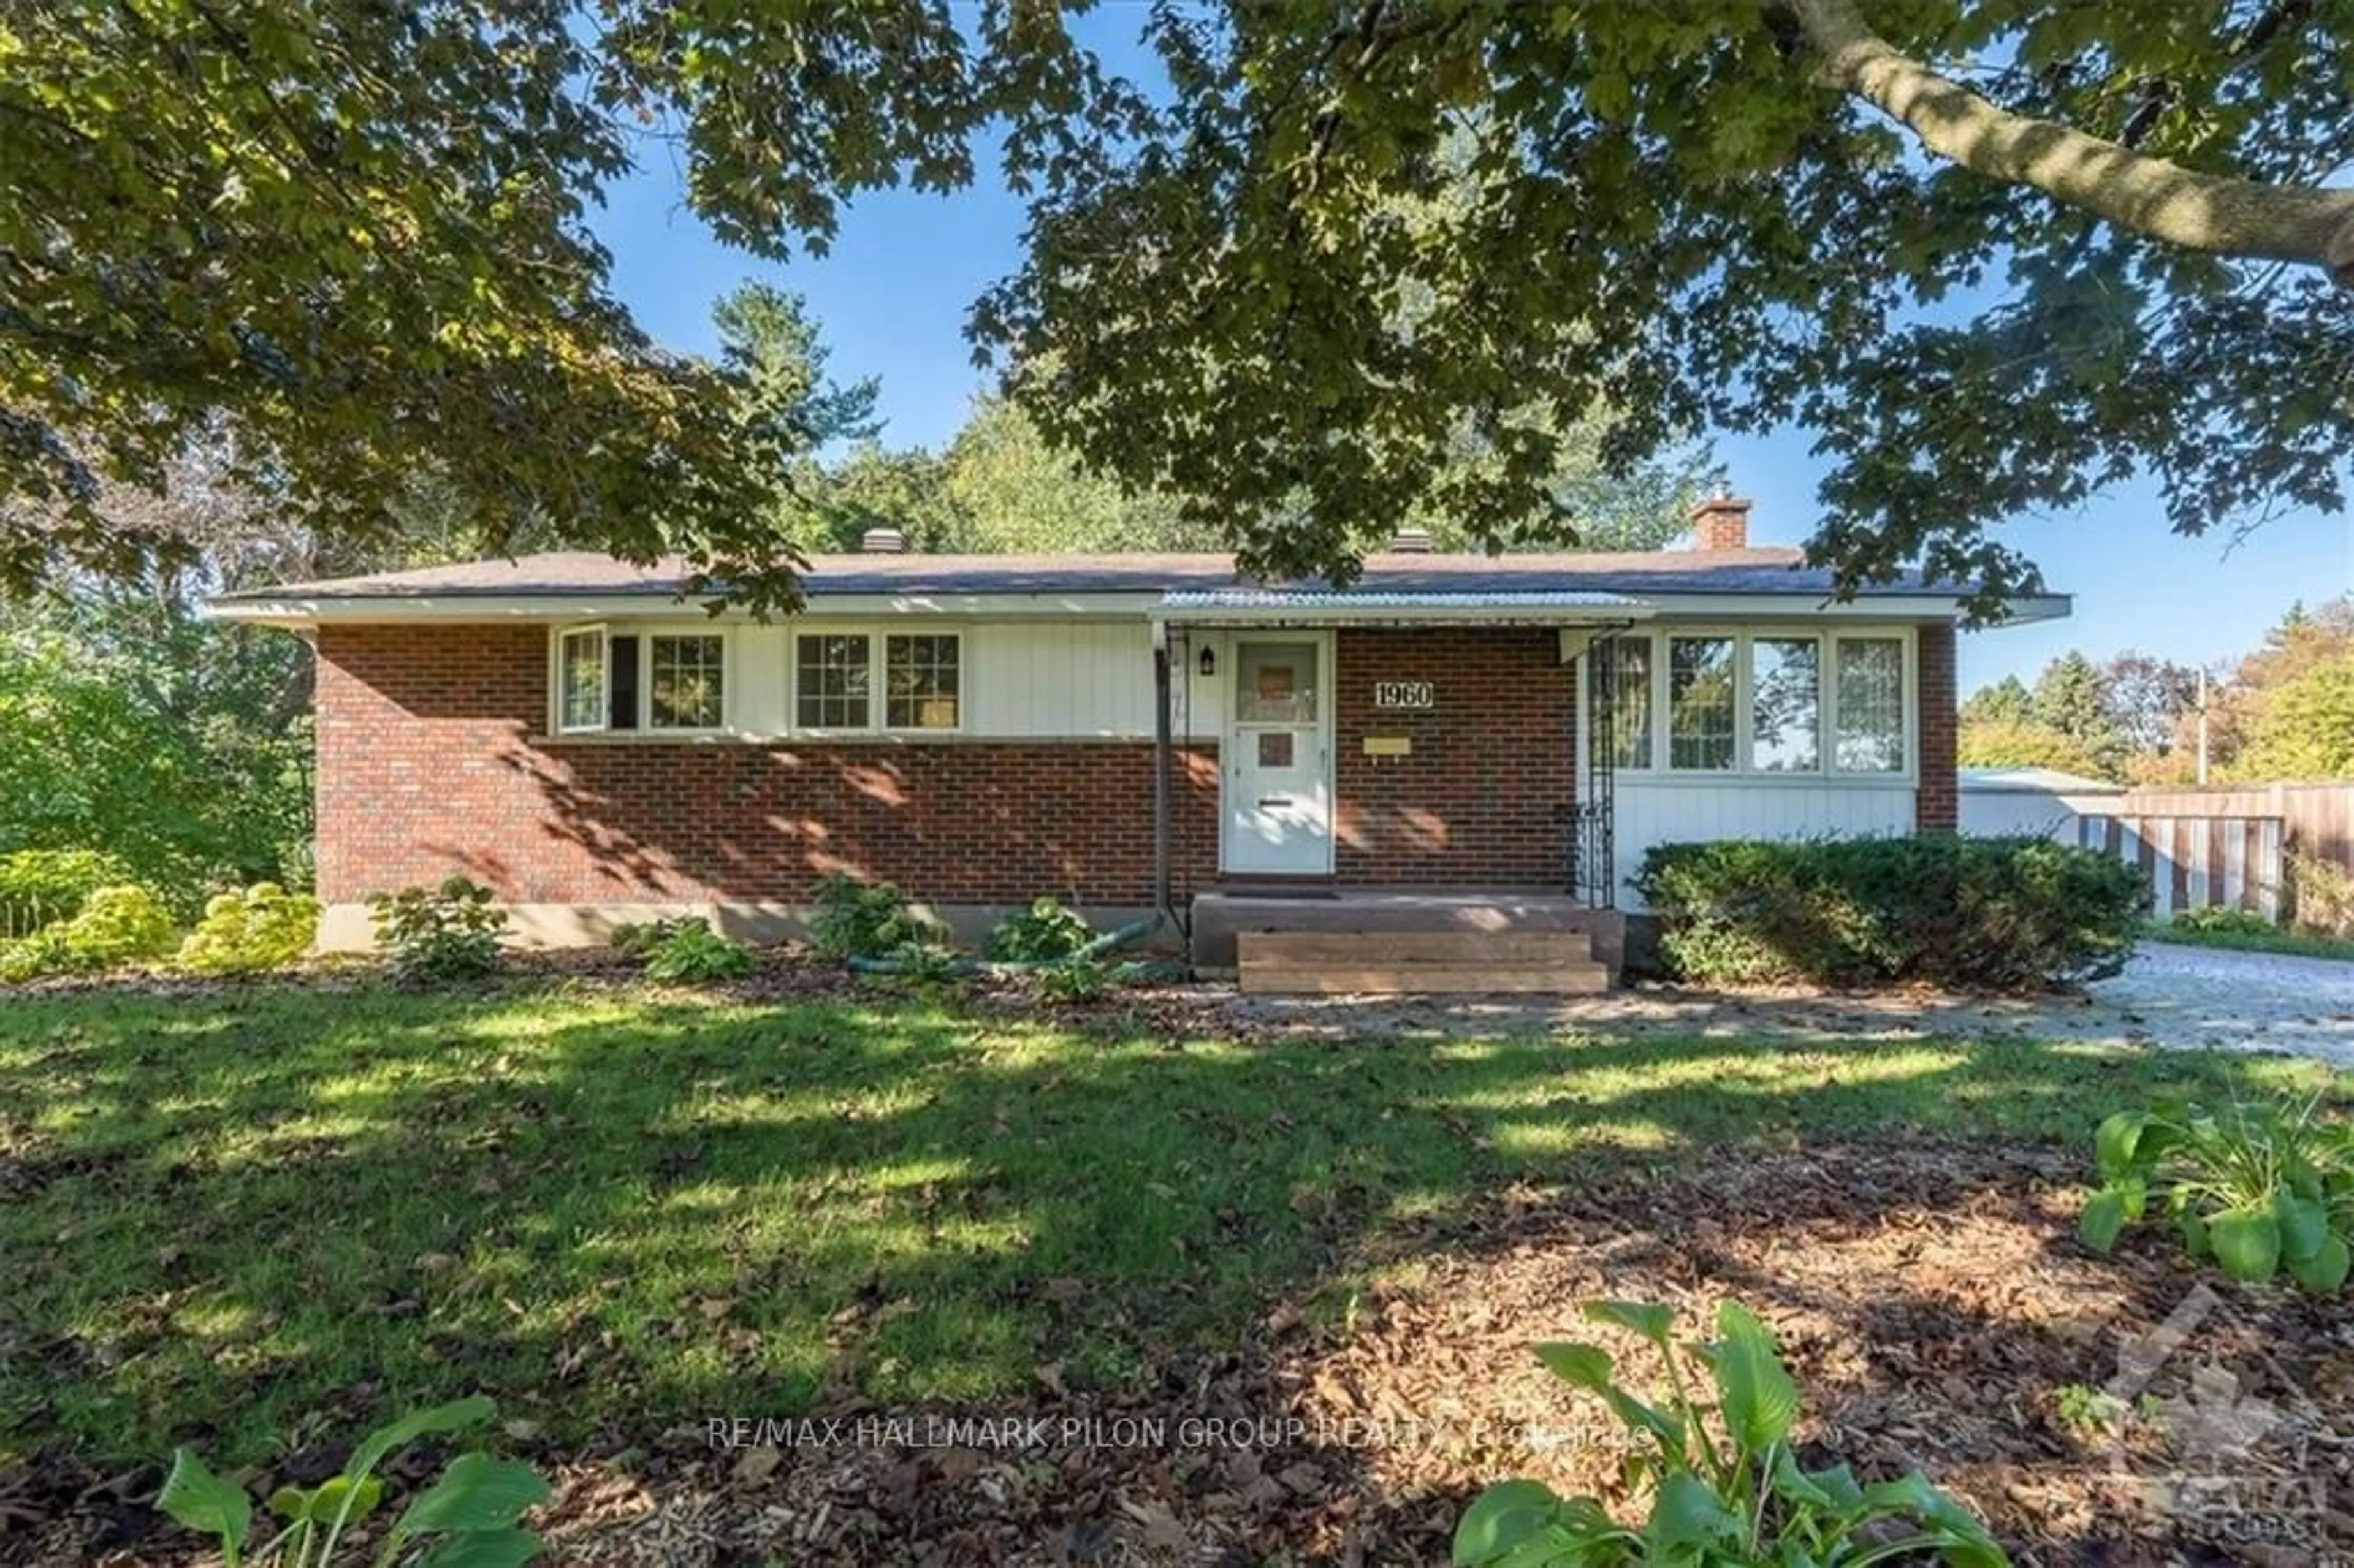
[0,0,2354,607]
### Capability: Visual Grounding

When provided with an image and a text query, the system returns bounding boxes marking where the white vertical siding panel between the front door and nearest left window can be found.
[965,619,1154,737]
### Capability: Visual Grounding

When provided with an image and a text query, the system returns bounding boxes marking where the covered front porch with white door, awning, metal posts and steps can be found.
[1154,588,1653,991]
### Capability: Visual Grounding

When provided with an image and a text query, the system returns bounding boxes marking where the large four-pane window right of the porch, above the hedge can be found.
[1586,629,1911,777]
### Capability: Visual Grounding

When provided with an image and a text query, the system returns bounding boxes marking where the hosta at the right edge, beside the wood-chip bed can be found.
[2079,1100,2354,1293]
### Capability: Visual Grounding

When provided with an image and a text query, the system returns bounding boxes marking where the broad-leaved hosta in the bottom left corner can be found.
[155,1398,549,1568]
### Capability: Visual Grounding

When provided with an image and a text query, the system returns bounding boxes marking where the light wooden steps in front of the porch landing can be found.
[1236,930,1610,996]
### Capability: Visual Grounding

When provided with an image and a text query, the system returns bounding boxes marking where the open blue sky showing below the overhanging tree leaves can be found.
[598,125,2354,690]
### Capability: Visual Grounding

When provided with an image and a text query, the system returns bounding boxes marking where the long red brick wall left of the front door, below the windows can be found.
[318,626,1217,904]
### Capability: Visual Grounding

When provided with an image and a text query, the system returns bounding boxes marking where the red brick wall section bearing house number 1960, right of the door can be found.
[1332,626,1575,890]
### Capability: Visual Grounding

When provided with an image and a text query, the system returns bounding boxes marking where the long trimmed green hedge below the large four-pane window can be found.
[1634,834,2149,991]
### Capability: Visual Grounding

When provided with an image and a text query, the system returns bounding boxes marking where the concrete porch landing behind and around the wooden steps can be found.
[1194,883,1626,989]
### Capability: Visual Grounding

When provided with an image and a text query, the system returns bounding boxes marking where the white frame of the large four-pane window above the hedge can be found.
[1577,622,1921,786]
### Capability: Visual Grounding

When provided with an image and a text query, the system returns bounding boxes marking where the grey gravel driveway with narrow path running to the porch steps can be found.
[1224,942,2354,1069]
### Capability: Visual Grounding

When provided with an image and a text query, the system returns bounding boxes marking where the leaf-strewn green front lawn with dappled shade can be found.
[0,989,2318,1464]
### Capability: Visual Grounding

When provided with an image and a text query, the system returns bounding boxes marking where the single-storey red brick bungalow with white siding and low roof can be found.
[214,497,2067,968]
